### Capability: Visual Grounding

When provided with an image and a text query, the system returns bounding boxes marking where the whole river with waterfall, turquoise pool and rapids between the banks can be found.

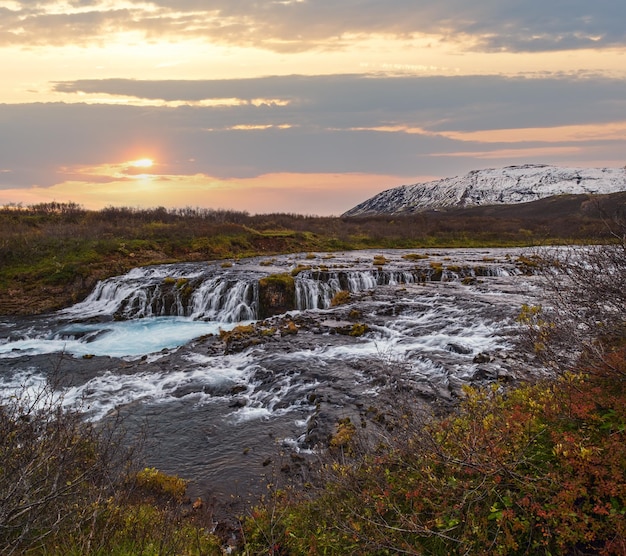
[0,249,540,508]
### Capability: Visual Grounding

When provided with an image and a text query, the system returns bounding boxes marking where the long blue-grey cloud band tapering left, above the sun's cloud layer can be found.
[55,74,626,131]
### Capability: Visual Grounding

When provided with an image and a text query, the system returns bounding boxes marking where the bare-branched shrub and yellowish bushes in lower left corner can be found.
[0,386,221,556]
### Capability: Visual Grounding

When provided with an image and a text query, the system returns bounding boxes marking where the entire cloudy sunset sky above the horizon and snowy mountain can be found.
[0,0,626,215]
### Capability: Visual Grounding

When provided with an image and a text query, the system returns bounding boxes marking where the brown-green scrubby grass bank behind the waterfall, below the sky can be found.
[0,203,609,314]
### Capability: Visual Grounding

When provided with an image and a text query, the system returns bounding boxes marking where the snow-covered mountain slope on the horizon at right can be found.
[343,164,626,216]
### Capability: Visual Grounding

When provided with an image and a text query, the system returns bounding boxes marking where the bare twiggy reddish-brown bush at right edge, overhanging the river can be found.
[521,235,626,376]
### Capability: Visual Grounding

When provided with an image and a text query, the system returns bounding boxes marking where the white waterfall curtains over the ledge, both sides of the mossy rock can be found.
[61,263,516,323]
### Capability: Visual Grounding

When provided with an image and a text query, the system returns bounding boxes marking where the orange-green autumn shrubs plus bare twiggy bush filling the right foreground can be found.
[244,240,626,556]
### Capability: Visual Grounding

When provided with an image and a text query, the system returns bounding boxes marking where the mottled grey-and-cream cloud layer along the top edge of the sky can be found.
[0,0,626,52]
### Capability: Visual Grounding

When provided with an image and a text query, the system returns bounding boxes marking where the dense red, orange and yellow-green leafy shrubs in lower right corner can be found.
[241,351,626,555]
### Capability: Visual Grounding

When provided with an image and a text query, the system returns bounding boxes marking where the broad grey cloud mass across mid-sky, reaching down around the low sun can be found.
[0,75,626,189]
